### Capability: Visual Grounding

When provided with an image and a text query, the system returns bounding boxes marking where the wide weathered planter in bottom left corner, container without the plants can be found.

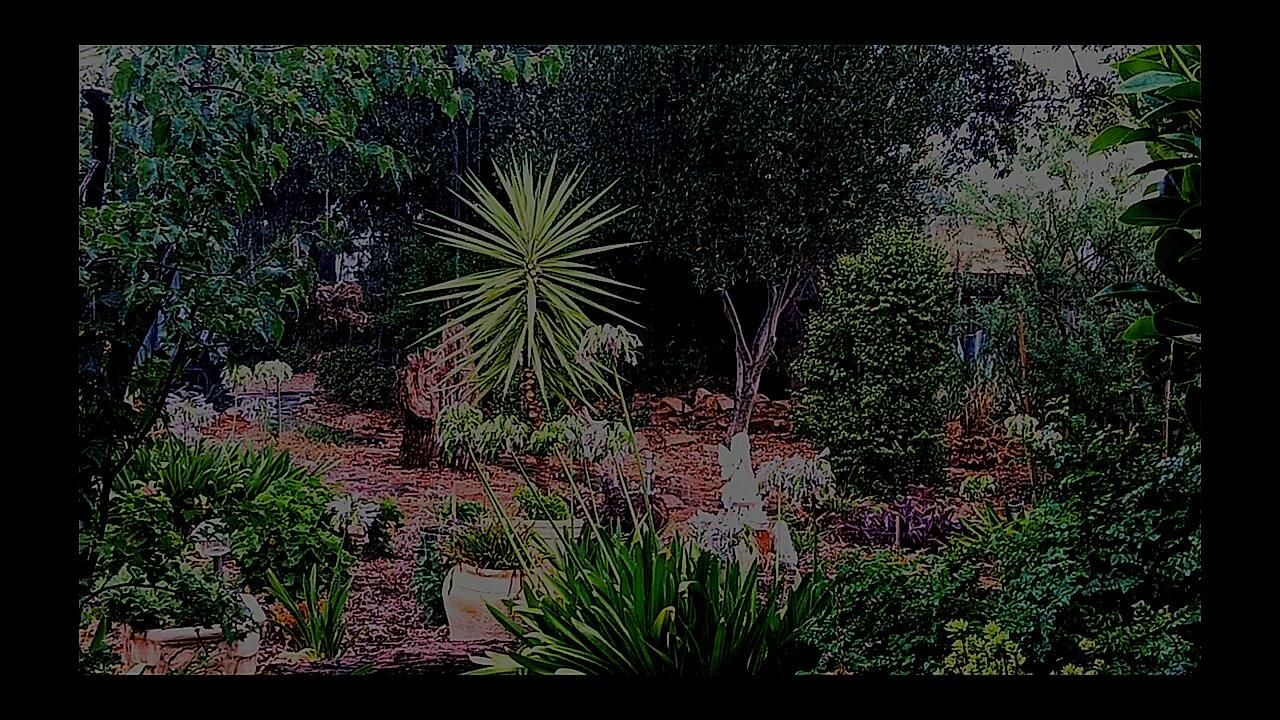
[124,594,266,675]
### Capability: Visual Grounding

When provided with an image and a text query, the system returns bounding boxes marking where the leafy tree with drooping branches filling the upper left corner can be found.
[77,46,559,575]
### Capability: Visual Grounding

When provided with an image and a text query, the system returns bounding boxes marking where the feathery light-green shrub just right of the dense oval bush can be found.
[947,128,1162,425]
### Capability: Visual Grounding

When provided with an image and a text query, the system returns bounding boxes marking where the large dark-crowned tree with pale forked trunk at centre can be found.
[488,46,1029,433]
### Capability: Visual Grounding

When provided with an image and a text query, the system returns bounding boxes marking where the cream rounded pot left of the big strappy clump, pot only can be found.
[440,564,524,641]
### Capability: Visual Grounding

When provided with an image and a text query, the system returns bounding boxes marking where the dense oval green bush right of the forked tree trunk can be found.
[796,233,955,493]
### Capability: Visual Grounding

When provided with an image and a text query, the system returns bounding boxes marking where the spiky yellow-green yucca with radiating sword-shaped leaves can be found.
[411,156,640,424]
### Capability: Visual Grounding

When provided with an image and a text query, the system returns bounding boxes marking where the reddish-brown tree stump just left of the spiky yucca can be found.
[397,325,475,468]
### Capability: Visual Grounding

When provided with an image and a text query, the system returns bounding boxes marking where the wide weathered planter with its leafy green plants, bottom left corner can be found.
[104,565,266,675]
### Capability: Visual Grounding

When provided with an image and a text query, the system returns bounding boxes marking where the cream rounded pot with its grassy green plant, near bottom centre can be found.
[440,518,527,641]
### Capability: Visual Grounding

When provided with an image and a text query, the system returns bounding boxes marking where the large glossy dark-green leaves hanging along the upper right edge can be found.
[1089,45,1204,427]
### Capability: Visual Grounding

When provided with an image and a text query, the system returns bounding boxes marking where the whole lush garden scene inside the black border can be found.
[76,45,1204,676]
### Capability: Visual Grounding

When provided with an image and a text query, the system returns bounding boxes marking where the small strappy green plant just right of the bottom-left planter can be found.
[266,565,352,659]
